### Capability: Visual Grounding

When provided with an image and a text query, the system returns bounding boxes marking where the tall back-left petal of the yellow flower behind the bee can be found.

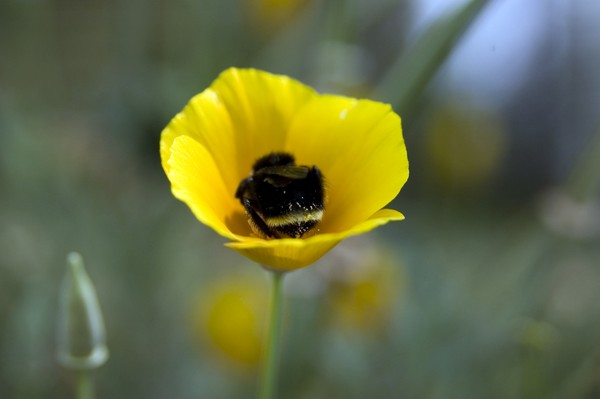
[160,68,316,225]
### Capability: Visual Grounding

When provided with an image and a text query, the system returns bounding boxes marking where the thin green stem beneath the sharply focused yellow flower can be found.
[259,272,284,399]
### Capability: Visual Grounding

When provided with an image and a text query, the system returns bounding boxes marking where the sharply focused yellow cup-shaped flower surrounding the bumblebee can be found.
[160,68,408,271]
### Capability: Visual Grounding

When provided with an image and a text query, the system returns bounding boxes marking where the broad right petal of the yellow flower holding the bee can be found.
[285,95,408,233]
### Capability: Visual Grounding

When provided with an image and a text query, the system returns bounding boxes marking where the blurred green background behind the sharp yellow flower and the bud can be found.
[0,0,600,399]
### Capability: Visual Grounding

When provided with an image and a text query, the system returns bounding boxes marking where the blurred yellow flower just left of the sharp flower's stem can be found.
[193,276,269,367]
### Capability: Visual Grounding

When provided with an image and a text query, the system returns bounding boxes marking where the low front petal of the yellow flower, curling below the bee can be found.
[225,209,404,271]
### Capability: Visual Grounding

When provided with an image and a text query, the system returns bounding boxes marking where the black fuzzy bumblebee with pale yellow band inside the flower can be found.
[235,152,325,238]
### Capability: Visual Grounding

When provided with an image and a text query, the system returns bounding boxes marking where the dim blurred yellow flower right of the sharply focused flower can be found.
[426,105,506,190]
